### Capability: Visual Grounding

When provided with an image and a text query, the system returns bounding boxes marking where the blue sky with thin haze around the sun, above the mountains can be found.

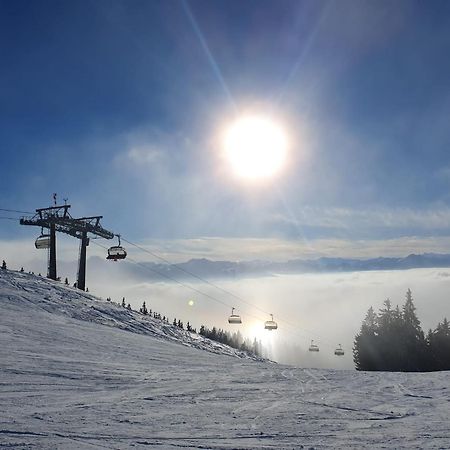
[0,0,450,259]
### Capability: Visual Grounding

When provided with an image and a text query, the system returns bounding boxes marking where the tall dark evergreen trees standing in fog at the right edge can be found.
[353,289,450,372]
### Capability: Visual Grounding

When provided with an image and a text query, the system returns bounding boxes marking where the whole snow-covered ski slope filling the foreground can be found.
[0,270,450,449]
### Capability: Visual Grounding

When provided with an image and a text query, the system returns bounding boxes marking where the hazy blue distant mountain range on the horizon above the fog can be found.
[118,253,450,281]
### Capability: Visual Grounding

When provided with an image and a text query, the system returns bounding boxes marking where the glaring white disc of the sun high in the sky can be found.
[225,116,287,180]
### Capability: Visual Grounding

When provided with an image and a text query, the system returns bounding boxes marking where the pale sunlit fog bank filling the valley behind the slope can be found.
[85,267,450,369]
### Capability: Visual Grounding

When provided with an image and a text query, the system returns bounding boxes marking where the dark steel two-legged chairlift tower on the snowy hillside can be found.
[20,201,115,291]
